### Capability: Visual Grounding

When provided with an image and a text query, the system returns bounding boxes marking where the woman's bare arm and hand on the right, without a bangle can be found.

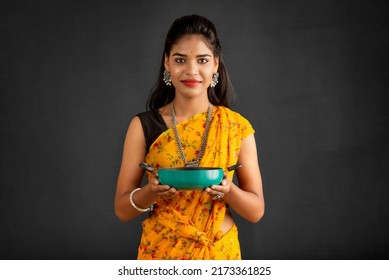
[207,134,265,223]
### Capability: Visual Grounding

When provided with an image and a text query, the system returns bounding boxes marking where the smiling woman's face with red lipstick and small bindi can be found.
[165,34,219,98]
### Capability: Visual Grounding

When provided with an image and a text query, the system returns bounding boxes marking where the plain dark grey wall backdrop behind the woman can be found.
[0,0,389,259]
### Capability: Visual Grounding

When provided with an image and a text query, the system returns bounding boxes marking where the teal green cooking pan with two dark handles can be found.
[139,162,242,190]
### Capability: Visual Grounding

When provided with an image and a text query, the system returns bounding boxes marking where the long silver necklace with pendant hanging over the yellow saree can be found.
[170,104,212,167]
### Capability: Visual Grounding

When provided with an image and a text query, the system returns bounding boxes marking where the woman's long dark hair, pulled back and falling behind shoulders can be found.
[147,15,233,110]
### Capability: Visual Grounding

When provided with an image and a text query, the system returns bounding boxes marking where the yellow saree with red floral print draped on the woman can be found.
[138,107,254,260]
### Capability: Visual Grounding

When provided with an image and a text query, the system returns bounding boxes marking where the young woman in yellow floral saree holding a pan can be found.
[115,15,264,259]
